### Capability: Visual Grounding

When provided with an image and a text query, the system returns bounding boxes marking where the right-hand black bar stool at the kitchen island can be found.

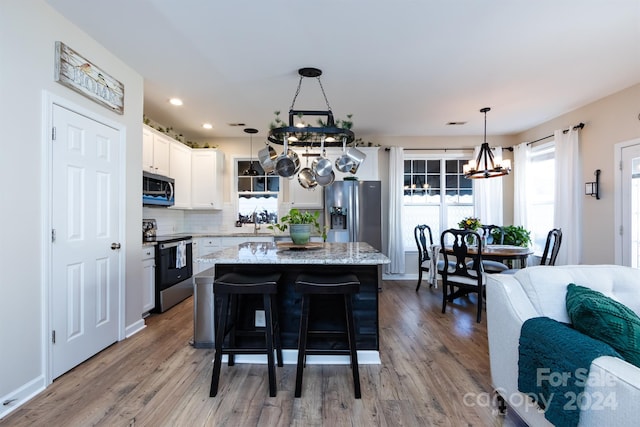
[294,273,361,399]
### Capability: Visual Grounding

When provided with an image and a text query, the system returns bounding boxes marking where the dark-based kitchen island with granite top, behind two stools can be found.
[194,242,389,363]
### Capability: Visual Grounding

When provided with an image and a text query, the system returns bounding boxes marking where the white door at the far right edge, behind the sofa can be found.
[620,144,640,268]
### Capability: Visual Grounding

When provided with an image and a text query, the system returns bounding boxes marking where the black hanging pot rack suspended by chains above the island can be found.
[267,68,355,147]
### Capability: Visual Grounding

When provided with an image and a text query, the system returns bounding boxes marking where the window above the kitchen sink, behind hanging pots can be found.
[236,160,280,224]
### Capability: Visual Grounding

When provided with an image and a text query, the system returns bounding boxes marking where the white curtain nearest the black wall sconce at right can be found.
[553,126,583,265]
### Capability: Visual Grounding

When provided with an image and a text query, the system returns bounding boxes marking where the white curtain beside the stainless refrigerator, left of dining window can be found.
[385,147,405,274]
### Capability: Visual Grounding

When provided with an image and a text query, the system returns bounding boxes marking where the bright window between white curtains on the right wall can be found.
[526,142,555,255]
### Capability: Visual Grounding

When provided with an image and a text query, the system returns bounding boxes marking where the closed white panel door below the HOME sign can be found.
[51,105,120,378]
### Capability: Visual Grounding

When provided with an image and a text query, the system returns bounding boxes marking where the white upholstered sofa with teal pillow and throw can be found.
[487,265,640,427]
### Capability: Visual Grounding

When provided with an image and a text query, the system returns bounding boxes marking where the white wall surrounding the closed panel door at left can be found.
[0,0,143,416]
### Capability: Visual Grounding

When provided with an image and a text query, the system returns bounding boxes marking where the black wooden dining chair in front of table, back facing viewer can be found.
[440,228,486,323]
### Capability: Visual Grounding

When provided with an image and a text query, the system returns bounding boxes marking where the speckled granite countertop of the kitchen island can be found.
[196,242,390,265]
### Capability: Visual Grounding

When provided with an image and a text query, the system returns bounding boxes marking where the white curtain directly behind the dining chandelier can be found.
[473,147,502,225]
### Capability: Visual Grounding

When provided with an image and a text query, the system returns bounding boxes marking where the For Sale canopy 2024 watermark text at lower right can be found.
[463,368,618,411]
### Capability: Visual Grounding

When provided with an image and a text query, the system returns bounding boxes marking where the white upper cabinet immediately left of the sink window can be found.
[191,149,224,209]
